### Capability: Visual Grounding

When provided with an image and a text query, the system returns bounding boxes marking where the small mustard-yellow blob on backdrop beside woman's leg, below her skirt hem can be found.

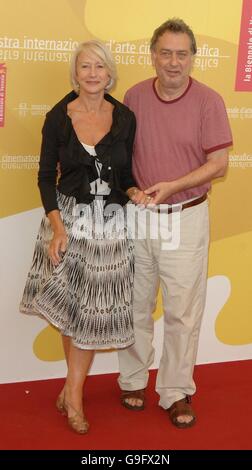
[33,325,65,362]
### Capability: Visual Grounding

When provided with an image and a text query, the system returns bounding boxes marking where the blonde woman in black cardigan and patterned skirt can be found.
[20,40,140,434]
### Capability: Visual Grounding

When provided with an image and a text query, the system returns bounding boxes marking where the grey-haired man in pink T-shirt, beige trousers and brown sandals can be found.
[119,18,232,428]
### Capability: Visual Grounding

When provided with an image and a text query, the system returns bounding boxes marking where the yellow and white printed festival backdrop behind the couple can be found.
[0,0,252,382]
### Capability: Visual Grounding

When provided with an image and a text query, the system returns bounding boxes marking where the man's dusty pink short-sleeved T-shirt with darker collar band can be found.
[124,77,232,204]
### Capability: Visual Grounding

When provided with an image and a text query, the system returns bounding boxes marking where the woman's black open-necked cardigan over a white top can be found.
[38,91,136,214]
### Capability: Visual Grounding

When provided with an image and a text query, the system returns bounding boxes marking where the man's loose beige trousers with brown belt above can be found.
[118,201,209,409]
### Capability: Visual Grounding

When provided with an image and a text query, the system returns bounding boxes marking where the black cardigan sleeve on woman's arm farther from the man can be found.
[38,112,59,214]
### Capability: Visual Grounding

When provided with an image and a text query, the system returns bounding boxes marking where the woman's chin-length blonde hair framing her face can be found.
[70,39,117,94]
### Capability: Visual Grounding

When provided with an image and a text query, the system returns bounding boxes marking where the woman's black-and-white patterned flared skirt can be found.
[20,193,134,349]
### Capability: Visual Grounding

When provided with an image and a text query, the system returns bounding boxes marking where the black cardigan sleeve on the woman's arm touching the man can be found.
[120,112,136,191]
